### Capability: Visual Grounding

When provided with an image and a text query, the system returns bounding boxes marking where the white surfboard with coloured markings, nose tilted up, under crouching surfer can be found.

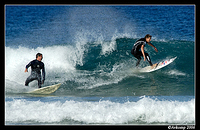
[139,57,177,72]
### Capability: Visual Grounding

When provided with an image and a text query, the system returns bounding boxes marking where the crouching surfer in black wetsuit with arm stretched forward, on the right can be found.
[131,34,158,67]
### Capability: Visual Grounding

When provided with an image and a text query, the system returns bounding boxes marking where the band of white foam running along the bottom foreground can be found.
[5,97,195,124]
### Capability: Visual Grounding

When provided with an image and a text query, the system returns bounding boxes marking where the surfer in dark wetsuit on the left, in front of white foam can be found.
[25,53,45,88]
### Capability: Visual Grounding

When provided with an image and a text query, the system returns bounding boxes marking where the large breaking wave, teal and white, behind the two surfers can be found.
[5,34,194,96]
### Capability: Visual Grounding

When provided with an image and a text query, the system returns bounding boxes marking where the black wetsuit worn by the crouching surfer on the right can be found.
[131,38,153,66]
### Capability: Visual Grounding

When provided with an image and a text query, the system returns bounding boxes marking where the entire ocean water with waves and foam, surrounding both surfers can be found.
[5,5,195,125]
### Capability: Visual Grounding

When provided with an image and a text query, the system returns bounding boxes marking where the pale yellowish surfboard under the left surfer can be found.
[27,83,61,94]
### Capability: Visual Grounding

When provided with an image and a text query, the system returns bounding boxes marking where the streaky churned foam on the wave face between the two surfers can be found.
[75,60,145,89]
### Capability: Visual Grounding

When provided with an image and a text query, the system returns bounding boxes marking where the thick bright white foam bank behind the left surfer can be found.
[5,45,83,84]
